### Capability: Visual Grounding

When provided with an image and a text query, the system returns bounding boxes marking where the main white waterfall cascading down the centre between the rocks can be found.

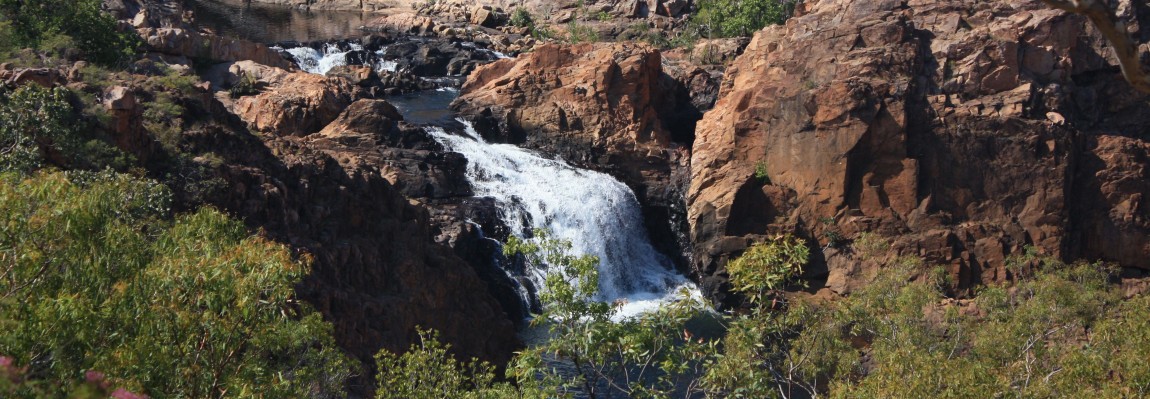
[428,121,698,319]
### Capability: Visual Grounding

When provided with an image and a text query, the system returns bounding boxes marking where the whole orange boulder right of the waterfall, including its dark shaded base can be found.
[452,43,693,269]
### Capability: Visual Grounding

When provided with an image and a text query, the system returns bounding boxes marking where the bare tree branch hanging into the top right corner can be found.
[1042,0,1150,93]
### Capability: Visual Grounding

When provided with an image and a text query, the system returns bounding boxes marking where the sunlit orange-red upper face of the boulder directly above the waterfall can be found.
[454,44,670,153]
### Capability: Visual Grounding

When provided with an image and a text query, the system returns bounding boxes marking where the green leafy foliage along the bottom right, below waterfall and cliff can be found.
[372,233,1150,398]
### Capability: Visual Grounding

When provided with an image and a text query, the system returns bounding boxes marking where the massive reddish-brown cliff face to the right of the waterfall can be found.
[688,0,1150,303]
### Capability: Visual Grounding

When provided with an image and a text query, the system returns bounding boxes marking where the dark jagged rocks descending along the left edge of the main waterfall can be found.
[307,100,529,322]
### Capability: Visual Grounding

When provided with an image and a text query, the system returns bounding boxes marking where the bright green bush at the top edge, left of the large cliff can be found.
[692,0,798,37]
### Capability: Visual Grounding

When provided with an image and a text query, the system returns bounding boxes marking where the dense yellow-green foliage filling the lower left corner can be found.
[0,171,351,398]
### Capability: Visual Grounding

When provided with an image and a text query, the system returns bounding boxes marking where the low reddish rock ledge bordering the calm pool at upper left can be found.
[137,28,296,70]
